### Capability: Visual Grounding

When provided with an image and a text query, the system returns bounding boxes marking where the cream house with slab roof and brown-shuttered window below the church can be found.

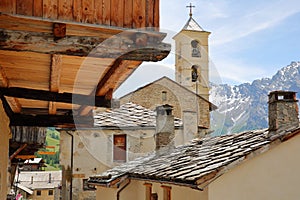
[60,103,206,199]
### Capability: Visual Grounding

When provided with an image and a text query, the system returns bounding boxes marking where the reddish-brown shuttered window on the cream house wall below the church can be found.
[113,135,127,162]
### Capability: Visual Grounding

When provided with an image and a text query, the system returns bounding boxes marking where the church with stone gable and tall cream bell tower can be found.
[120,5,217,136]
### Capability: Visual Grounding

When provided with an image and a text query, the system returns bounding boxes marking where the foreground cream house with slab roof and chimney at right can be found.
[89,91,300,200]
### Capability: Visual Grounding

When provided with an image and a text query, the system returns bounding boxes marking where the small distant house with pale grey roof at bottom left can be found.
[15,171,61,200]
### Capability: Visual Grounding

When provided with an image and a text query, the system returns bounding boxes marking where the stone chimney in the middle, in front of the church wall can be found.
[155,104,175,150]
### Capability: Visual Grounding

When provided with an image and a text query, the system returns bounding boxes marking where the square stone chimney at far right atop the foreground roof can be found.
[269,91,299,131]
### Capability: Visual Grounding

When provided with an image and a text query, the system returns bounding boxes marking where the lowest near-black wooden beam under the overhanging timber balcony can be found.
[10,113,94,127]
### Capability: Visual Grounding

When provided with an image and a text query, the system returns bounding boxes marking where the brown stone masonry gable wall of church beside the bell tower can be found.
[120,78,210,128]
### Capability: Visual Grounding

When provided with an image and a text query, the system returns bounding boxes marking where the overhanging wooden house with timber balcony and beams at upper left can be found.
[0,0,171,199]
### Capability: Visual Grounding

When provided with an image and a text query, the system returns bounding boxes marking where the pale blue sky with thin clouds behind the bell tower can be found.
[116,0,300,96]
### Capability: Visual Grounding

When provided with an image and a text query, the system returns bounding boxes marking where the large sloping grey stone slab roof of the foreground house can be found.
[89,126,300,190]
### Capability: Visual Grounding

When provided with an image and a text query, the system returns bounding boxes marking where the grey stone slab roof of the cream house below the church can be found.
[94,103,182,128]
